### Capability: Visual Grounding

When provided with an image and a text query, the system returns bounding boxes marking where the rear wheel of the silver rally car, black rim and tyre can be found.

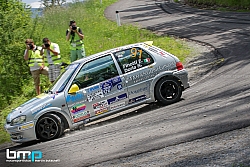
[155,78,182,105]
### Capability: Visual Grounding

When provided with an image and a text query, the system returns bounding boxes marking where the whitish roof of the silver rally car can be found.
[72,41,153,64]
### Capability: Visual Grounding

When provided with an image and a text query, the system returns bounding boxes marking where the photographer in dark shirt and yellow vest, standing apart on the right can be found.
[66,20,85,62]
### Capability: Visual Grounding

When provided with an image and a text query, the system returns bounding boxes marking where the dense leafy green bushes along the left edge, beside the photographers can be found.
[0,0,42,109]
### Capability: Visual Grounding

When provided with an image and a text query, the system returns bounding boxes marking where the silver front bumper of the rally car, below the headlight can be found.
[4,121,37,143]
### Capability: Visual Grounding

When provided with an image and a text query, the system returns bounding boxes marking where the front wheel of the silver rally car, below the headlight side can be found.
[36,114,64,141]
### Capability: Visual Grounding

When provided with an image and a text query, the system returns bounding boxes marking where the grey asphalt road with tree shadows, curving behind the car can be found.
[0,0,250,167]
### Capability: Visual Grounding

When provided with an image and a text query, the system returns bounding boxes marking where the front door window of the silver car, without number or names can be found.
[73,55,119,89]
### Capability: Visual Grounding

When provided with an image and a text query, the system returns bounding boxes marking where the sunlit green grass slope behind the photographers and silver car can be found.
[0,0,192,143]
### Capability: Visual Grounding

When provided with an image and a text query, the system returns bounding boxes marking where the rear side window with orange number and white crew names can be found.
[114,47,154,73]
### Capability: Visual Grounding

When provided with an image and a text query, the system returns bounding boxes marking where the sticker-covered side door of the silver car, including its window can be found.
[67,55,128,122]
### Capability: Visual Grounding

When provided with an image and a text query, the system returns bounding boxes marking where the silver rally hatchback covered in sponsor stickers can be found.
[5,41,189,143]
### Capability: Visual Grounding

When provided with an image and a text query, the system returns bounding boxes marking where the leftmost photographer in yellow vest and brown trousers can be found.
[24,39,48,95]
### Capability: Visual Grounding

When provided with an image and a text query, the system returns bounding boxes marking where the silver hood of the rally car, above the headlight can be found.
[6,93,53,123]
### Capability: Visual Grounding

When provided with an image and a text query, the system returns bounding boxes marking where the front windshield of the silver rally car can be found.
[48,63,80,93]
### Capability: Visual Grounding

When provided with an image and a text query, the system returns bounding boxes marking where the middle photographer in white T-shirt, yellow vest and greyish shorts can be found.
[40,38,62,83]
